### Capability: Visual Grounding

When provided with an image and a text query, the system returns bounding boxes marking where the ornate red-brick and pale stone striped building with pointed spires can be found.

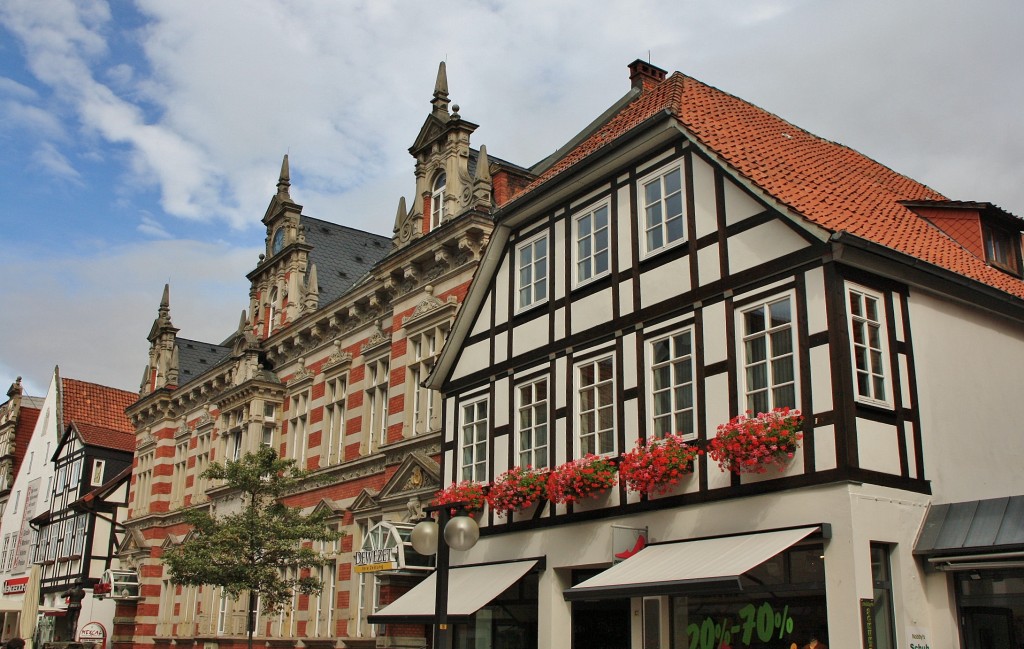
[115,63,528,647]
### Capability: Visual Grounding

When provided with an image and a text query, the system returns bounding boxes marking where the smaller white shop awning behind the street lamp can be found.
[369,559,537,624]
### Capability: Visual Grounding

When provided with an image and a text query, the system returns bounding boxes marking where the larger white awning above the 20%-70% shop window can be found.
[563,526,819,601]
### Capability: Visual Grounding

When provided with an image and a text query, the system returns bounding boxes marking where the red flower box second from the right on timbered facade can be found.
[618,435,699,495]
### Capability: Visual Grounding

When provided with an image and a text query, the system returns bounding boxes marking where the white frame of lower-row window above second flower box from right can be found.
[647,327,697,440]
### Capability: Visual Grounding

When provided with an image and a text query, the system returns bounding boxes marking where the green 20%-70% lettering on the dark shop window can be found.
[686,602,800,649]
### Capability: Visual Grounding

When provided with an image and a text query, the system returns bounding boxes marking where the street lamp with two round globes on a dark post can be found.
[410,503,480,649]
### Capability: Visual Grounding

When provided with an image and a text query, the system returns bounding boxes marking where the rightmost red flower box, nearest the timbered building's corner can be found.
[708,407,804,474]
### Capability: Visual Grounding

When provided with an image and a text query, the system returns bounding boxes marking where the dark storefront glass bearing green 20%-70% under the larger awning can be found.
[670,544,828,649]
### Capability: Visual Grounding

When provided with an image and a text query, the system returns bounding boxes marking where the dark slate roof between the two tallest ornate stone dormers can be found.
[299,215,391,303]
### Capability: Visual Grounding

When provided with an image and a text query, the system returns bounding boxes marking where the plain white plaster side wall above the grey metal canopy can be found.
[908,291,1024,503]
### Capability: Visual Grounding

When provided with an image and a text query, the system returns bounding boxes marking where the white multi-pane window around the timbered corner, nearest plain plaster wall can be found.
[846,287,889,403]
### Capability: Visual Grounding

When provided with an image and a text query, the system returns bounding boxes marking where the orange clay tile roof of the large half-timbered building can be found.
[516,73,1024,298]
